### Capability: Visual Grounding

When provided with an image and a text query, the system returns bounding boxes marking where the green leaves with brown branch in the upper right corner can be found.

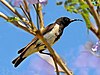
[58,0,100,39]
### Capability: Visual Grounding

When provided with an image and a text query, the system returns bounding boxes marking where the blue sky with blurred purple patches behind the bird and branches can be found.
[0,0,100,75]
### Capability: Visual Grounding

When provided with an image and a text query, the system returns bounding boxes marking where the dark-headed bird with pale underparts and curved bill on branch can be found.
[12,17,82,67]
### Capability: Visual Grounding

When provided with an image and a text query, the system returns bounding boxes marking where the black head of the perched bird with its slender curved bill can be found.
[55,17,82,27]
